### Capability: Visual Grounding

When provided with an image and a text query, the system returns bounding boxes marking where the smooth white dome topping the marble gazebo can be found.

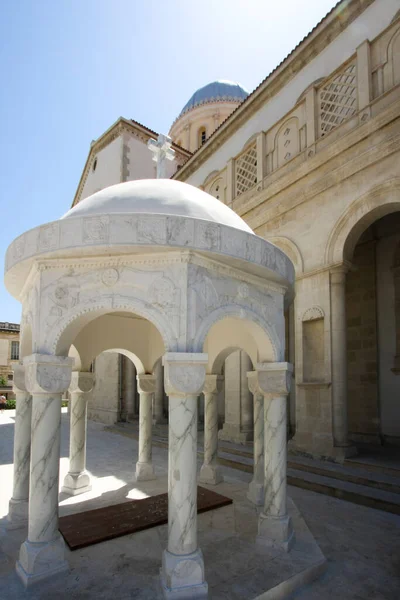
[61,179,253,233]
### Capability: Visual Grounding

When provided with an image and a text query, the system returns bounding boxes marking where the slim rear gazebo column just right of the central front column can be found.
[199,375,224,485]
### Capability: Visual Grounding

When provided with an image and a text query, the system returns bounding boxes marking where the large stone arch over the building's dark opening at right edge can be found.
[325,178,400,265]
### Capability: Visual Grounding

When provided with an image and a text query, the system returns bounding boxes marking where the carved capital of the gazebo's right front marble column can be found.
[247,362,293,396]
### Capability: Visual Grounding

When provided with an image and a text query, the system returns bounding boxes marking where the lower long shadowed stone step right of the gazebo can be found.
[287,468,400,515]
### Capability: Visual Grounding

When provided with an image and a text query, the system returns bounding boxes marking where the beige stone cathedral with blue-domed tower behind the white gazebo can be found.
[69,0,400,460]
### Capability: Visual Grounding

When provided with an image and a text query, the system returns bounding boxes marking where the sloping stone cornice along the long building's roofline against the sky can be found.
[173,0,374,181]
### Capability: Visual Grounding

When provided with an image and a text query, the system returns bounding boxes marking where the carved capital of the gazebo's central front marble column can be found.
[163,352,208,396]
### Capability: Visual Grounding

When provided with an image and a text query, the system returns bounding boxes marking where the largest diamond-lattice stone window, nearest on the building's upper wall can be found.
[318,61,357,136]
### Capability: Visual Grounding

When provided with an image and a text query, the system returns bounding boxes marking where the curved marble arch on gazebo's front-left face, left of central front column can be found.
[44,297,173,356]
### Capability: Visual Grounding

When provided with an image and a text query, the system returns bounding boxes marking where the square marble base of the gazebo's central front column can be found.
[160,549,208,600]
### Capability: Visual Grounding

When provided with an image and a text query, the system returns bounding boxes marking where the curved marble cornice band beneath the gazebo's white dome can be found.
[5,213,294,297]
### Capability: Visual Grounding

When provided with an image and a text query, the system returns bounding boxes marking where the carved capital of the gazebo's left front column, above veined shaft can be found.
[23,354,74,394]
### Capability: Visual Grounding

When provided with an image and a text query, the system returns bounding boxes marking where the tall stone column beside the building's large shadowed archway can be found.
[330,267,356,457]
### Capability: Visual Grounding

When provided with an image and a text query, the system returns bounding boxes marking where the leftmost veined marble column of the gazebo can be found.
[6,365,32,529]
